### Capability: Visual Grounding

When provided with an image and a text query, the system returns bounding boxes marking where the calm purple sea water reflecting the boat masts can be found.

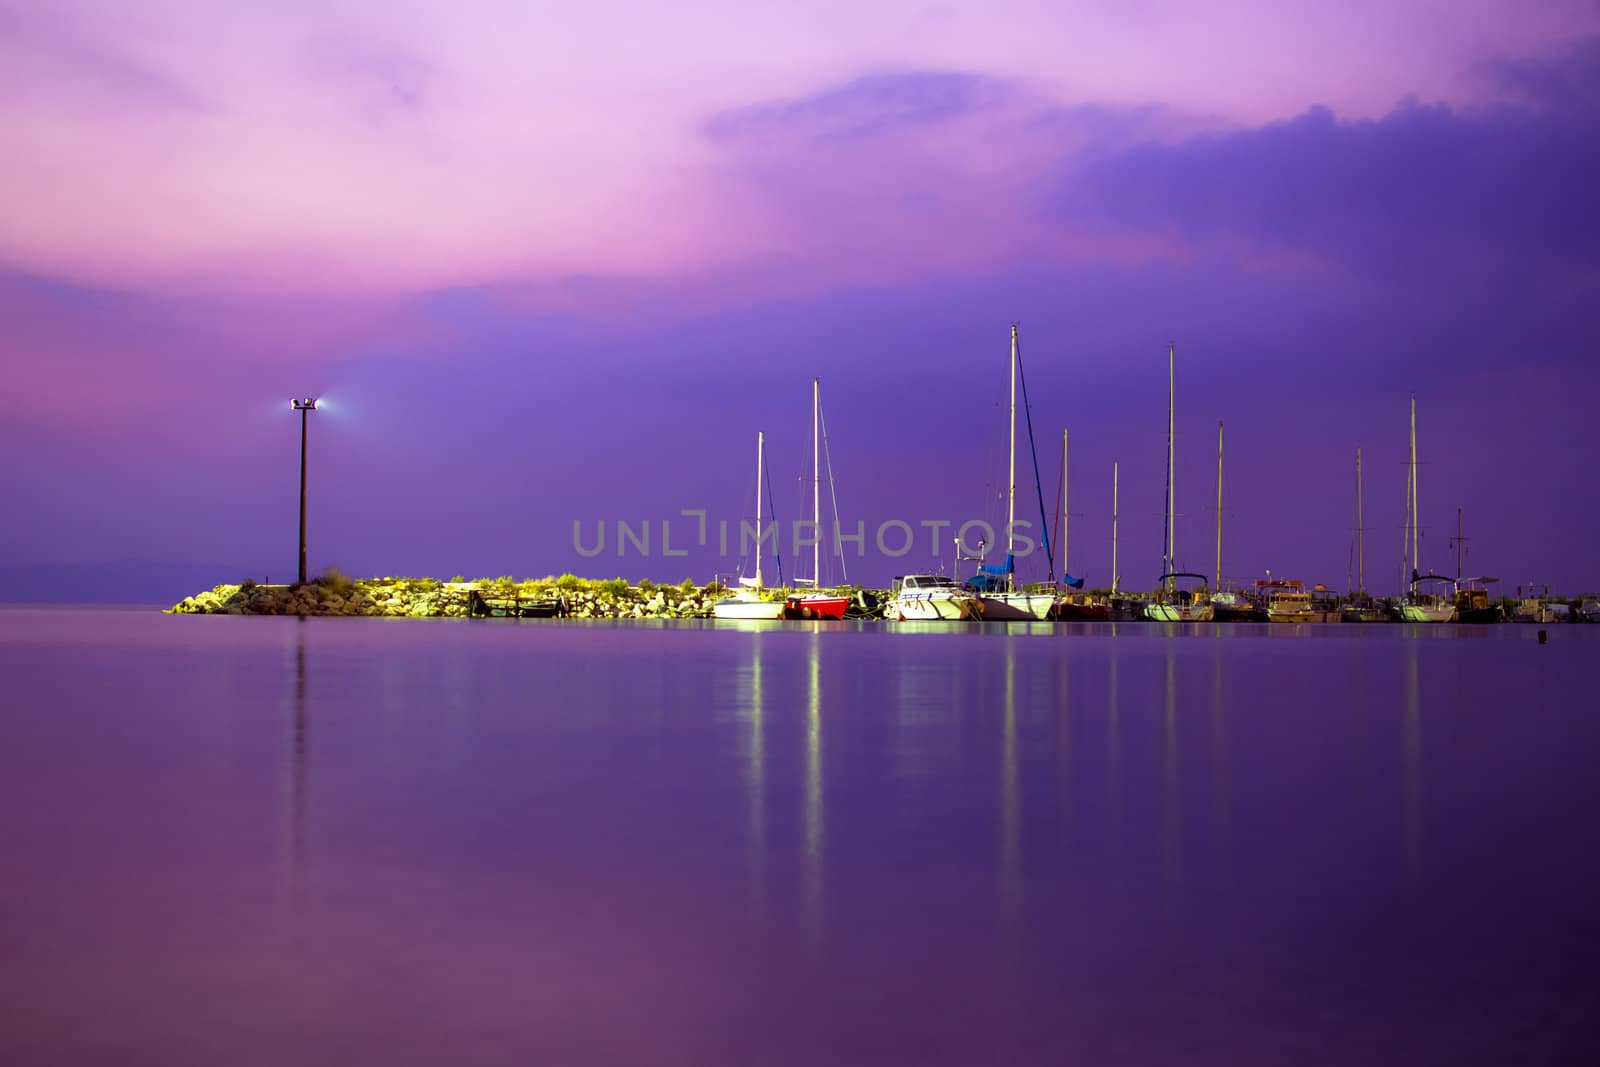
[0,609,1600,1067]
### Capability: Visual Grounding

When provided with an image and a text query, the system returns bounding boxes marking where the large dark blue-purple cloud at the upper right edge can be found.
[1064,88,1600,280]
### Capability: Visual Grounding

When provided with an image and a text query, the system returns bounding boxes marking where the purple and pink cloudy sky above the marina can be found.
[0,0,1600,600]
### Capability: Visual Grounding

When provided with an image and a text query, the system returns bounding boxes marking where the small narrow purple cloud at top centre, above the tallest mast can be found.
[706,72,1010,141]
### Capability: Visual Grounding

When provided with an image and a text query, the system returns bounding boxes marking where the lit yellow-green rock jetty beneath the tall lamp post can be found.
[168,571,752,619]
